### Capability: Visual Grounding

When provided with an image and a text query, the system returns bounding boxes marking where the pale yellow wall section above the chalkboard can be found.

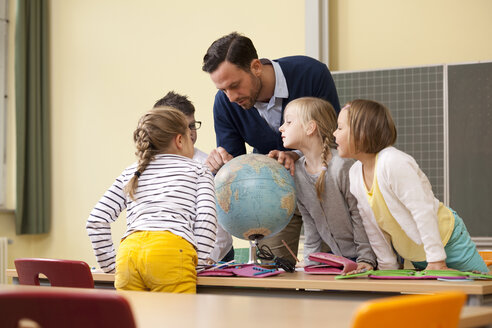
[329,0,492,71]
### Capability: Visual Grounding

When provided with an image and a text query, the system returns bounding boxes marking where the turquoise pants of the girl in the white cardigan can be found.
[412,209,489,273]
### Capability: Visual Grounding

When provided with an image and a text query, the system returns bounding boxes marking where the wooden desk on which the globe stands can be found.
[7,269,492,306]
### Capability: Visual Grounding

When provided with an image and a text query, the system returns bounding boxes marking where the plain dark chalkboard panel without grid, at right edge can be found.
[448,63,492,237]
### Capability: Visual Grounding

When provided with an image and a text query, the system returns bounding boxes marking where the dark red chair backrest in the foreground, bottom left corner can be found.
[0,289,136,328]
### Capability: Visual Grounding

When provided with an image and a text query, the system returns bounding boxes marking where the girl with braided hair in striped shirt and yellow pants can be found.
[87,107,217,293]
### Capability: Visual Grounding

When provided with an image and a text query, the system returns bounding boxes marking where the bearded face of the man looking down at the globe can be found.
[210,61,261,109]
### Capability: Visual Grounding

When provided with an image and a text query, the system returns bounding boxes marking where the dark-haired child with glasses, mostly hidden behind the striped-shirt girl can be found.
[154,91,234,262]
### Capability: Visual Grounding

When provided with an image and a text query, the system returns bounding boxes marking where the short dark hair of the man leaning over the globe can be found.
[202,32,258,73]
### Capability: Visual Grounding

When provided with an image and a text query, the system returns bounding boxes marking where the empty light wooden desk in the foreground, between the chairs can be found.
[0,285,492,328]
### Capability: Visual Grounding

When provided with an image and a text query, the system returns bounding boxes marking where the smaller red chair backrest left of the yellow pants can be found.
[14,258,94,288]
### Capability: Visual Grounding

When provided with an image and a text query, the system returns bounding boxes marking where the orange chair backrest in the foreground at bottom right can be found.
[352,292,466,328]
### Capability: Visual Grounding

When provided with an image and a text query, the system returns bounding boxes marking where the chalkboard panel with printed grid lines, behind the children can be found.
[333,65,446,201]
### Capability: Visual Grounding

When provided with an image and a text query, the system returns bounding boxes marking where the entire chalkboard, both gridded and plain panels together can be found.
[333,62,492,237]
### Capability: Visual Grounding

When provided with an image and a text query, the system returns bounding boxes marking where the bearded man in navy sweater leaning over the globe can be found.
[202,32,340,258]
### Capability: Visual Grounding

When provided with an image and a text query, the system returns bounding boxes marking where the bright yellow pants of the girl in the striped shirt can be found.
[114,231,198,294]
